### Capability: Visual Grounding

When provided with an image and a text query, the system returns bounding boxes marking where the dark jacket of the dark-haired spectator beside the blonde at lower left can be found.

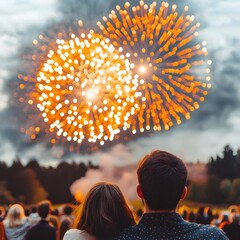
[25,220,57,240]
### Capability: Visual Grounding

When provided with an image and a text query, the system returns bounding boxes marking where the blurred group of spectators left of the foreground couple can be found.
[0,200,74,240]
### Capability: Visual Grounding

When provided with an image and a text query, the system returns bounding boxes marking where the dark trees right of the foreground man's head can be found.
[188,145,240,204]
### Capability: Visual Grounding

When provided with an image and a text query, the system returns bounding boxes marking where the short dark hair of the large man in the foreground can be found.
[137,150,187,210]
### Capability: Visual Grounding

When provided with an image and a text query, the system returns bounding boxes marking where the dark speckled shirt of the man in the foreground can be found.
[114,212,228,240]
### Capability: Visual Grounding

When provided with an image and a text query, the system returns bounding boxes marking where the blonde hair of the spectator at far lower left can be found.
[4,204,27,228]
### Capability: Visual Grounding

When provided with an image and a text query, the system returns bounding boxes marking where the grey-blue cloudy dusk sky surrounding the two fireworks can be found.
[0,0,240,167]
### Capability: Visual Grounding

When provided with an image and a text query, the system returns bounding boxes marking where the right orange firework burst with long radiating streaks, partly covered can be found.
[97,1,211,132]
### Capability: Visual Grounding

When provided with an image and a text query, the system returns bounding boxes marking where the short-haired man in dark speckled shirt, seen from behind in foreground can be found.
[114,150,228,240]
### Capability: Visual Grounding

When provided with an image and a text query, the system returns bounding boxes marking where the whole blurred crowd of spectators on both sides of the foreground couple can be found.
[0,200,240,240]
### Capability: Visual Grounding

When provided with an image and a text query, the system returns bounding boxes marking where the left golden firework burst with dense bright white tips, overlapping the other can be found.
[22,30,141,145]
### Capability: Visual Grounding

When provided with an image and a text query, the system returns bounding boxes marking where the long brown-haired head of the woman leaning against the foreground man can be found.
[76,182,135,239]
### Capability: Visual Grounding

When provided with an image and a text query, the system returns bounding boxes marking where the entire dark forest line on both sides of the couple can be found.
[0,146,240,204]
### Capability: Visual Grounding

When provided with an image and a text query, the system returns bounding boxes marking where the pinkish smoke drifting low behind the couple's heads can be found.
[70,144,207,201]
